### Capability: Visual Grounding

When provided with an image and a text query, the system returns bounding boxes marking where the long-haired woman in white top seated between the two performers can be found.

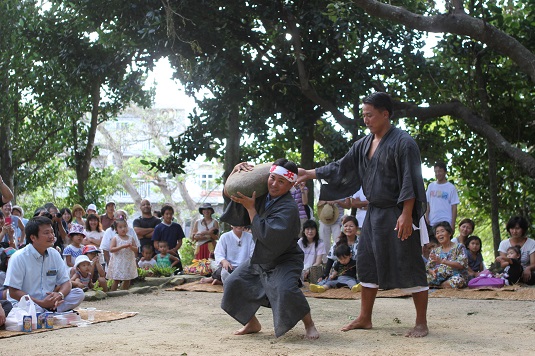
[297,220,325,282]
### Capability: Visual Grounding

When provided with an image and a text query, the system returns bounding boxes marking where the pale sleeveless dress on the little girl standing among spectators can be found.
[106,235,139,281]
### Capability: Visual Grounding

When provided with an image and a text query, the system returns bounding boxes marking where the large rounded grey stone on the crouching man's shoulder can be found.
[225,163,272,197]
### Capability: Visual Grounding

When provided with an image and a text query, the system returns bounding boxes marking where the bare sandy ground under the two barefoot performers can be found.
[0,290,535,356]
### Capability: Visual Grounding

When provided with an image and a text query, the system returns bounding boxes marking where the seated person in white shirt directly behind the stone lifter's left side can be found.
[201,226,255,285]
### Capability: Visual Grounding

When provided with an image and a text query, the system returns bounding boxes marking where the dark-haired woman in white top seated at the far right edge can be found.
[498,216,535,285]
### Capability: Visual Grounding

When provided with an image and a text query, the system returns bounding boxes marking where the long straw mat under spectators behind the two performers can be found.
[166,282,535,300]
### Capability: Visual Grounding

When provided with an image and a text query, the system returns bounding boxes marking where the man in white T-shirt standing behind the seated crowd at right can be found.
[425,162,459,231]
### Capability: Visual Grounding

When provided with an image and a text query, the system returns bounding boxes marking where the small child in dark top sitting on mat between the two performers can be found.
[310,244,360,293]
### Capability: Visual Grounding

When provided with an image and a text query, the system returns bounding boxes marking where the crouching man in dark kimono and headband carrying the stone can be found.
[221,159,319,339]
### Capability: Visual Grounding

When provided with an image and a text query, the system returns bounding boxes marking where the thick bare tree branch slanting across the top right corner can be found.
[353,0,535,82]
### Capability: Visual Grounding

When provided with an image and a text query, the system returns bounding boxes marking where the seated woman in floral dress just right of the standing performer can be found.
[426,221,468,288]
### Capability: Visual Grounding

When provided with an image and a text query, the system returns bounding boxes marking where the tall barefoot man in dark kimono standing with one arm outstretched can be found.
[298,93,429,337]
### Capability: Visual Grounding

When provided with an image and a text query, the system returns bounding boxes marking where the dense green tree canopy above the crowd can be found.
[0,0,535,253]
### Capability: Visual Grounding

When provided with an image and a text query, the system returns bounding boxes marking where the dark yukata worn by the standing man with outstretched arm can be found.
[316,127,427,289]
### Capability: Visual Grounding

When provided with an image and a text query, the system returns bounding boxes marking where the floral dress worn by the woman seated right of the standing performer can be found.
[426,243,468,288]
